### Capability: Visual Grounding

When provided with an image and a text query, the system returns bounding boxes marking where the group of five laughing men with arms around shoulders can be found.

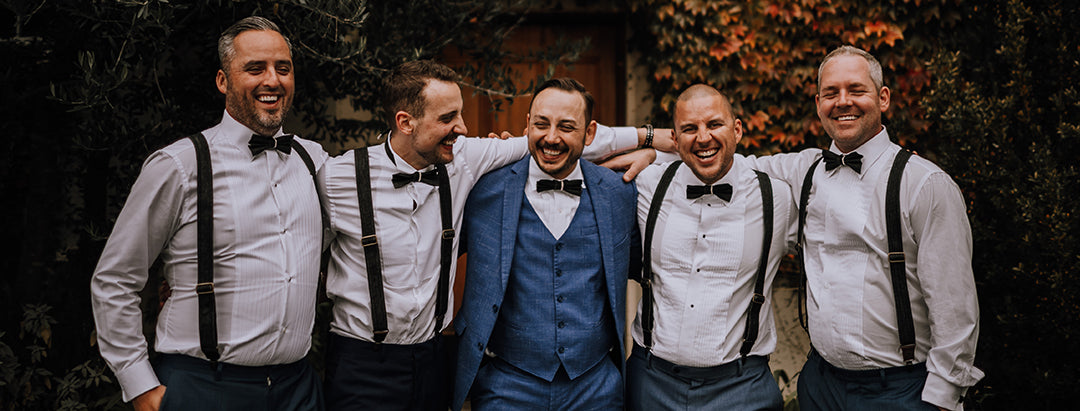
[91,17,982,410]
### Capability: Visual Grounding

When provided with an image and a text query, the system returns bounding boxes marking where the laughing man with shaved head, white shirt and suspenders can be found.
[626,84,797,410]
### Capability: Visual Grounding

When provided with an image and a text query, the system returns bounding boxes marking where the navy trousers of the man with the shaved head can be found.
[626,344,783,411]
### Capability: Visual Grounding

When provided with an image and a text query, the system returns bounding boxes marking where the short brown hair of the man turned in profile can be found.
[382,60,461,127]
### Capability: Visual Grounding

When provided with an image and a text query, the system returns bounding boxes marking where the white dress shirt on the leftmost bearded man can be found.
[91,113,327,401]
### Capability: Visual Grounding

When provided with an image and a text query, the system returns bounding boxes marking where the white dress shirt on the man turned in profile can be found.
[320,126,637,344]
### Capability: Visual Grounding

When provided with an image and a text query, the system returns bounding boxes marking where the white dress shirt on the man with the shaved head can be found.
[632,157,798,367]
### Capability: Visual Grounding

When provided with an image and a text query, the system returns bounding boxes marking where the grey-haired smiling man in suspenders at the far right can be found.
[748,45,983,410]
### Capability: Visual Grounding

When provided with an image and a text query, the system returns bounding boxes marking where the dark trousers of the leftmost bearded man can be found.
[154,354,324,411]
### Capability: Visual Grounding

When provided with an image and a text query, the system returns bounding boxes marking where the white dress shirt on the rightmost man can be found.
[747,129,983,409]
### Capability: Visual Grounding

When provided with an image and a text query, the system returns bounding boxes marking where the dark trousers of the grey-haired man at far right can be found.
[798,348,937,411]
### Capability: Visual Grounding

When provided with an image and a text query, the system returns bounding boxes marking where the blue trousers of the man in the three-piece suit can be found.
[470,356,623,411]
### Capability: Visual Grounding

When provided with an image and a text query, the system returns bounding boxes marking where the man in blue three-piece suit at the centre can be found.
[453,79,640,410]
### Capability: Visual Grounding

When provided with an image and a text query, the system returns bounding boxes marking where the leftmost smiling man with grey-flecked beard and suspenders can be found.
[91,17,326,411]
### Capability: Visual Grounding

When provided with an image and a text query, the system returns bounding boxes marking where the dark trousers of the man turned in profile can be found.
[326,333,457,411]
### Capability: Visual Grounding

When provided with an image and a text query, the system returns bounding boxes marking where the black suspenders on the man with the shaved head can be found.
[640,161,773,358]
